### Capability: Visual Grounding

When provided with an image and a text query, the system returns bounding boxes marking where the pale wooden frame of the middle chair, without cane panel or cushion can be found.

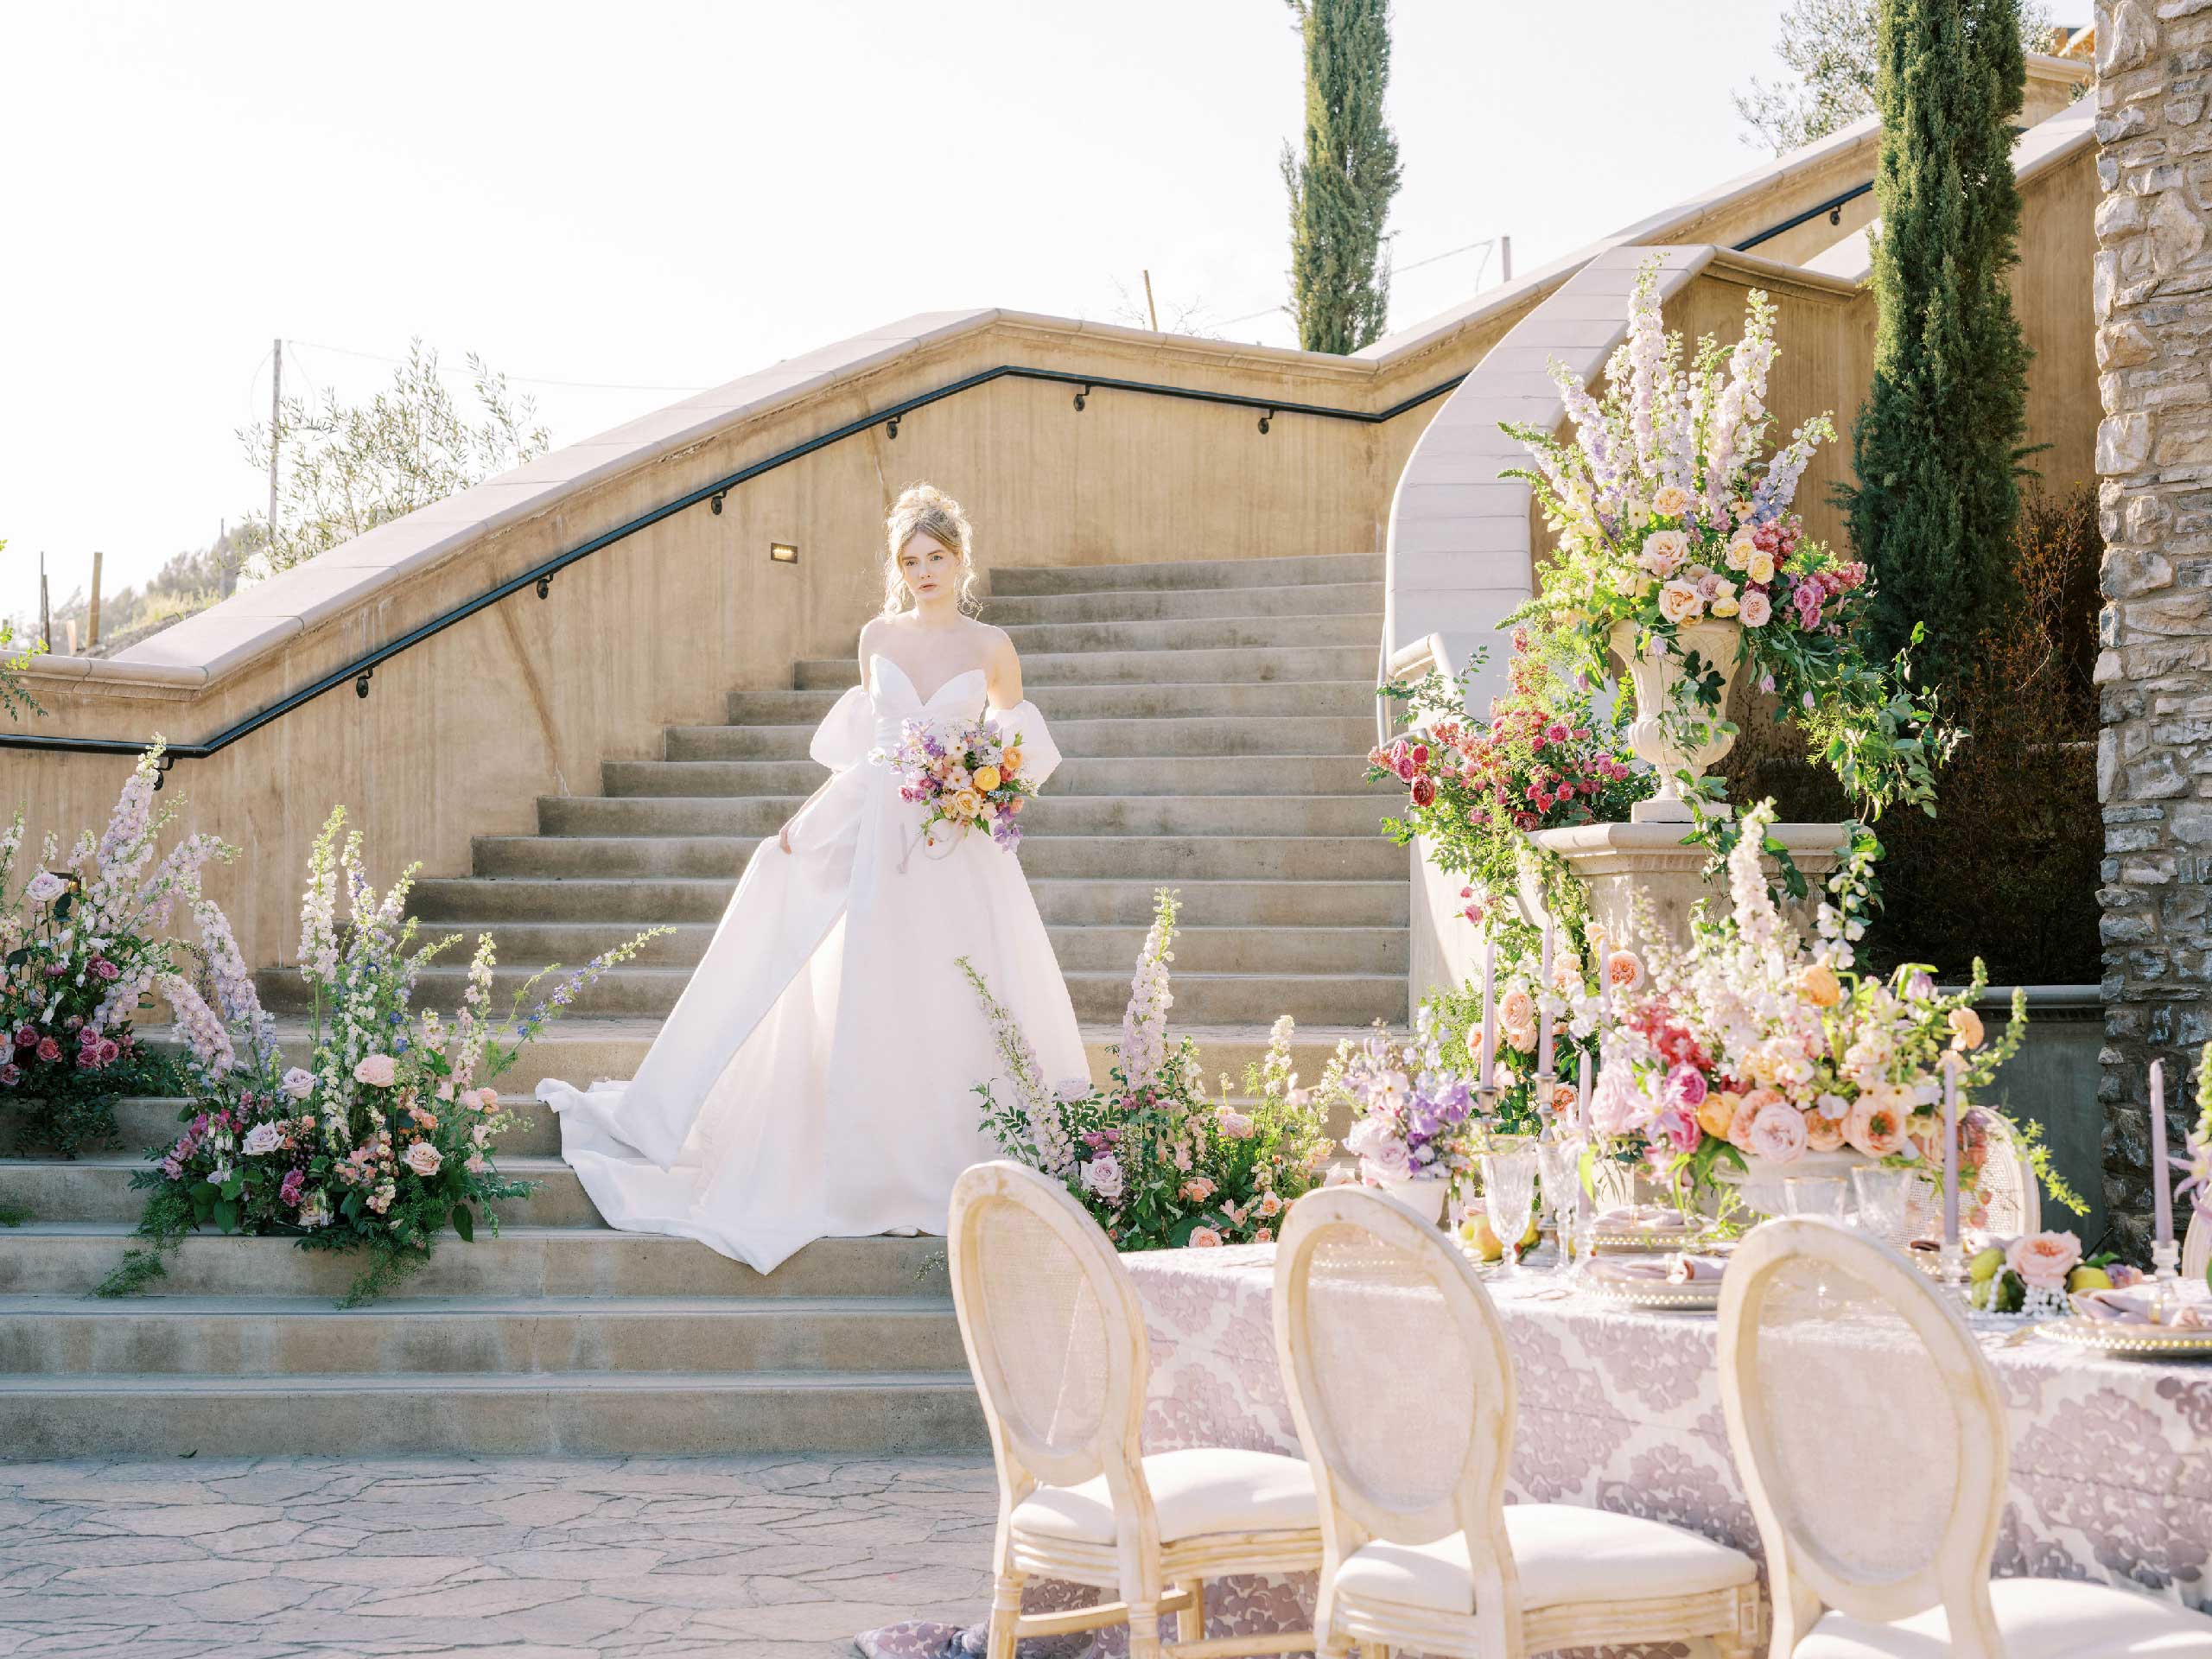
[1274,1185,1761,1659]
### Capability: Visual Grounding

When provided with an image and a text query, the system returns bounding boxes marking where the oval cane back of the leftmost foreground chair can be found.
[947,1164,1150,1513]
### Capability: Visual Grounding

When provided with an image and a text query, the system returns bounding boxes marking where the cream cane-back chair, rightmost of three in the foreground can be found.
[1721,1219,2212,1659]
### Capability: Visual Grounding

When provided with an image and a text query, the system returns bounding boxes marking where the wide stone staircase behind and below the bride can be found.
[0,556,1409,1458]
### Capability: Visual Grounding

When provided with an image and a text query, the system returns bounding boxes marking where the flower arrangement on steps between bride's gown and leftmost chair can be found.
[960,887,1330,1249]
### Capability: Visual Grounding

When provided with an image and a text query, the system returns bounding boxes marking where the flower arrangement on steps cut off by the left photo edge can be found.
[0,743,219,1157]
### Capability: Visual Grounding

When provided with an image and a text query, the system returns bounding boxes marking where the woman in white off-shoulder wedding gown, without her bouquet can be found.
[537,485,1086,1272]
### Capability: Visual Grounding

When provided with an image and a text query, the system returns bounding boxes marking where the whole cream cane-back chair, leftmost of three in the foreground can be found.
[947,1164,1320,1659]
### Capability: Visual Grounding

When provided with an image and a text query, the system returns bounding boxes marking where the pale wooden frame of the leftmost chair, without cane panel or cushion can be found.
[947,1161,1320,1659]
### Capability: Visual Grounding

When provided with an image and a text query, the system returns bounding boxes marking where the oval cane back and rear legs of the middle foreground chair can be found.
[1274,1185,1522,1652]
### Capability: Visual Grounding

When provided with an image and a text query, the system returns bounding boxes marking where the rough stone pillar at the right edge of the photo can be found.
[2094,0,2212,1255]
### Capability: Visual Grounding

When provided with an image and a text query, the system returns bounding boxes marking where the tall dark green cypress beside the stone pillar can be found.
[1840,0,2031,686]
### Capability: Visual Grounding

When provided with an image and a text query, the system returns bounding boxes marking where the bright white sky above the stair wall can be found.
[0,0,1783,632]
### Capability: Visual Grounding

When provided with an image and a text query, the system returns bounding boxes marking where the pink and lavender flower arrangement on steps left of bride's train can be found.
[98,807,666,1307]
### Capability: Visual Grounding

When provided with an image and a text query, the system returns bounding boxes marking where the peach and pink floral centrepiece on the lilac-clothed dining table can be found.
[1591,803,2084,1212]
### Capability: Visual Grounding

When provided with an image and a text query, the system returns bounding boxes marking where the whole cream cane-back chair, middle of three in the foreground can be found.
[1274,1185,1761,1659]
